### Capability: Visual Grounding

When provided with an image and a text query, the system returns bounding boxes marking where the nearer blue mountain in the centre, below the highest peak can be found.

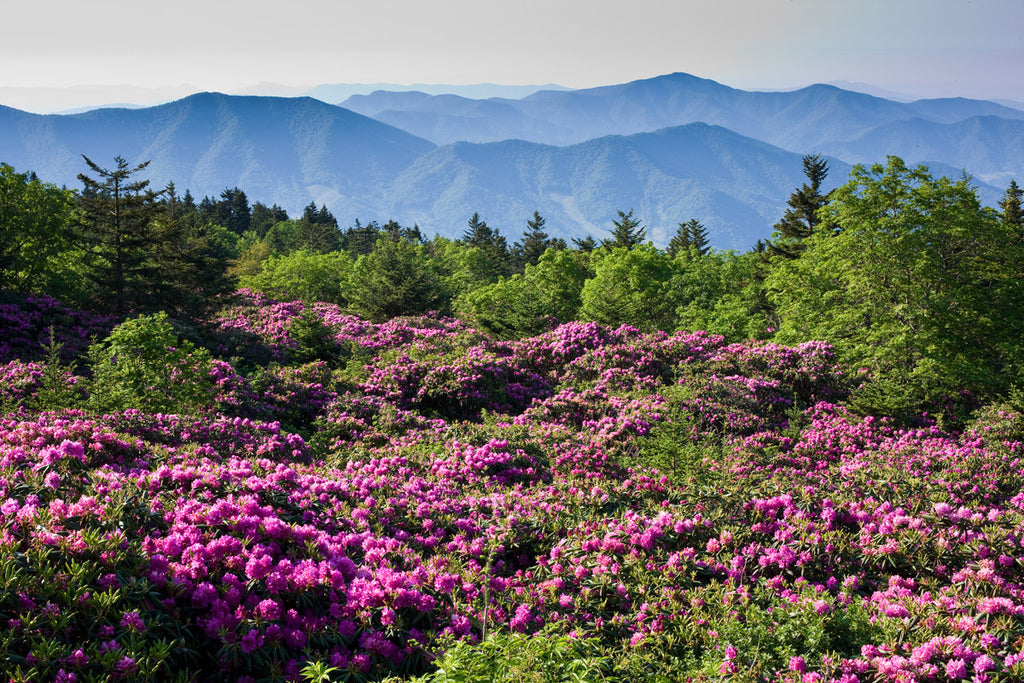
[388,124,850,249]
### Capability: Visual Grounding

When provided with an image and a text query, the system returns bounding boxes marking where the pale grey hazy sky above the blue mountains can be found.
[0,0,1024,109]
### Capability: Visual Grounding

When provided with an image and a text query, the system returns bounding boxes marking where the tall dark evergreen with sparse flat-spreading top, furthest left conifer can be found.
[76,156,163,314]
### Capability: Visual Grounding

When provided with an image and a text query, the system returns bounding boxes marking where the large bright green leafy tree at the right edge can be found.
[767,157,1024,405]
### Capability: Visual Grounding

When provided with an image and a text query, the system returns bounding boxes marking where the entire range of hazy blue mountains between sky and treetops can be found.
[0,74,1011,249]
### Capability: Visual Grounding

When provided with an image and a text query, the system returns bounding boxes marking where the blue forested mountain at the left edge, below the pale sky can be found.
[0,93,434,215]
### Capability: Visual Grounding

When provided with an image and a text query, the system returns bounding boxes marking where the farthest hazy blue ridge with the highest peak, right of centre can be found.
[342,74,1024,182]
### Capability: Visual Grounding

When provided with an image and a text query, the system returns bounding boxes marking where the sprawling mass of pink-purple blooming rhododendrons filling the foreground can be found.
[0,290,1024,683]
